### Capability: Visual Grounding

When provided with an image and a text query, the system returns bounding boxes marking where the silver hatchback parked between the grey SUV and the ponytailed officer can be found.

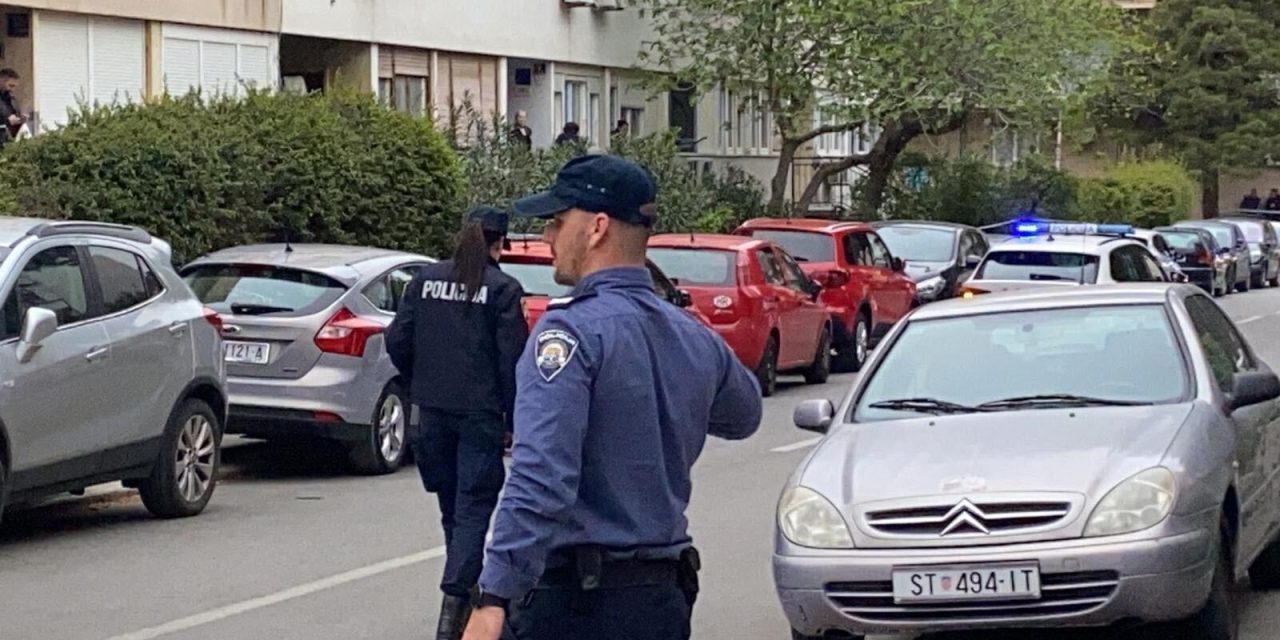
[182,244,431,474]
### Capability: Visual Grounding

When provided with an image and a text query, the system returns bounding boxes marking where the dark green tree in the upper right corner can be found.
[1093,0,1280,218]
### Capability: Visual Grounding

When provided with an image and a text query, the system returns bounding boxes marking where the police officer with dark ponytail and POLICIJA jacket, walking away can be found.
[387,207,529,640]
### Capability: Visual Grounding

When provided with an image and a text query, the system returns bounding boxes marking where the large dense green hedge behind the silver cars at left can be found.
[0,92,462,261]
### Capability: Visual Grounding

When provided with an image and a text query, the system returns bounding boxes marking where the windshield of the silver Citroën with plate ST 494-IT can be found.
[854,305,1187,421]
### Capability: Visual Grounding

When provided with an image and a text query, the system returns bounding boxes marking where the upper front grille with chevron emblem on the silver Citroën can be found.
[865,500,1071,538]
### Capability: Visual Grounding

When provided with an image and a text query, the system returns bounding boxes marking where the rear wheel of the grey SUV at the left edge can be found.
[138,398,223,518]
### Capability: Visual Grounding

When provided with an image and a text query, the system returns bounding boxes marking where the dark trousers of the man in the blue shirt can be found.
[504,582,692,640]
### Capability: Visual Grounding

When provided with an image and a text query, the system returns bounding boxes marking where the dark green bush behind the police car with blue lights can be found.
[884,155,1076,227]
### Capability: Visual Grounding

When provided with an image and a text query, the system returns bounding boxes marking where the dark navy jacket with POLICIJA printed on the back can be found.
[387,260,529,416]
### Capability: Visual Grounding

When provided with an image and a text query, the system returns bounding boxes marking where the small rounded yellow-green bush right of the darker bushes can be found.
[1075,161,1196,228]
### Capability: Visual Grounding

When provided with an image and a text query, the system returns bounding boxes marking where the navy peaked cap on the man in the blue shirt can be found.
[512,155,658,227]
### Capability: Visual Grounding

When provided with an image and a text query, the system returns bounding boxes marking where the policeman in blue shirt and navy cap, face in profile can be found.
[463,156,760,640]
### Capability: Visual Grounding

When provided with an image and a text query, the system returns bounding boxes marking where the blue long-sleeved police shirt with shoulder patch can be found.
[480,266,760,599]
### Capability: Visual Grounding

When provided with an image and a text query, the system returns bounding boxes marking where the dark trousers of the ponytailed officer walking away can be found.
[412,408,506,598]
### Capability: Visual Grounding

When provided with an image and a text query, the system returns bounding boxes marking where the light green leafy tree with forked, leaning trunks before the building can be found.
[641,0,1119,212]
